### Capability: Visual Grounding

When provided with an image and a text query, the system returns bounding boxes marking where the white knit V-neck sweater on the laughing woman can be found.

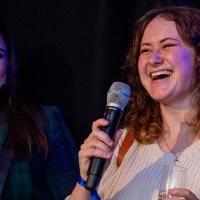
[98,131,200,200]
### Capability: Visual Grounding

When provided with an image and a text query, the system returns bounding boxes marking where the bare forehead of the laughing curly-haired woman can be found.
[142,16,180,42]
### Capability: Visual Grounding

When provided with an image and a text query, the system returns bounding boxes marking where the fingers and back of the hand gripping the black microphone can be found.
[79,119,119,180]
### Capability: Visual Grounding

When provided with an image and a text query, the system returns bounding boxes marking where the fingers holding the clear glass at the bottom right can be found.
[168,188,199,200]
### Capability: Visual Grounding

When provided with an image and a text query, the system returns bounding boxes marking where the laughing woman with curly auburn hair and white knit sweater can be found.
[65,7,200,200]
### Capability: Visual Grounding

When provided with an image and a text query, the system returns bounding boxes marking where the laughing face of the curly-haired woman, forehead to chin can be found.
[138,16,196,104]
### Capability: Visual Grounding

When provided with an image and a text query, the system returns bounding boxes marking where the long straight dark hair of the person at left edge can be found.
[0,22,48,160]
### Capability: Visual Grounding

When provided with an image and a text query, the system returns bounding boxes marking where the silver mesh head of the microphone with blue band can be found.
[107,82,131,111]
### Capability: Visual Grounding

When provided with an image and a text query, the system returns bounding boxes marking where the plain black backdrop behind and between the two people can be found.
[0,0,200,145]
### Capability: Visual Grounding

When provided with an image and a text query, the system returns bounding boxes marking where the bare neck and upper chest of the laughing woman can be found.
[159,105,195,152]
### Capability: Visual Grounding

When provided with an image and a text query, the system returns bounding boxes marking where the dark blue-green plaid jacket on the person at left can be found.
[0,106,78,200]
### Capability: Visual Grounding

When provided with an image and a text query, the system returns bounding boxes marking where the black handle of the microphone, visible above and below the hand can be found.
[85,106,122,191]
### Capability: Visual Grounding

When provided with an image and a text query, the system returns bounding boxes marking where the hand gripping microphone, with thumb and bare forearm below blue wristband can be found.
[68,119,122,200]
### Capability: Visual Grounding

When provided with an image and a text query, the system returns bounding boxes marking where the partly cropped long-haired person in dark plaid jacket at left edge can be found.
[0,22,78,200]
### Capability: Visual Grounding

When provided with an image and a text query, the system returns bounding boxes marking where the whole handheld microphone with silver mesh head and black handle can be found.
[85,82,131,191]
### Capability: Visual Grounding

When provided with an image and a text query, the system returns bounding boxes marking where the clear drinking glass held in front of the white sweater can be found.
[158,166,187,200]
